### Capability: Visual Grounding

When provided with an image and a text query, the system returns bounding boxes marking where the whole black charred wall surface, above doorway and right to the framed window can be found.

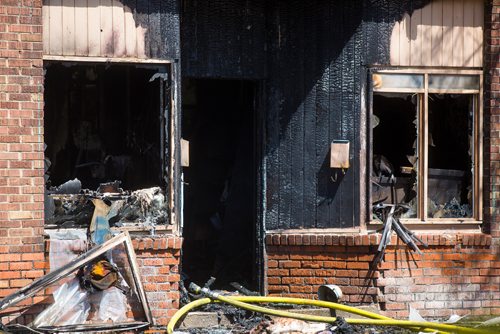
[181,0,428,229]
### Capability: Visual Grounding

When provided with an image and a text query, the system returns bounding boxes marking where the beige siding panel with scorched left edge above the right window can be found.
[390,0,484,67]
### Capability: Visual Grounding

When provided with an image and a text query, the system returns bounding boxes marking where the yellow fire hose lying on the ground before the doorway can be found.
[167,284,495,334]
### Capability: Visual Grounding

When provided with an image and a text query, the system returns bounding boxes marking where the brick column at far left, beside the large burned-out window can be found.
[0,0,44,310]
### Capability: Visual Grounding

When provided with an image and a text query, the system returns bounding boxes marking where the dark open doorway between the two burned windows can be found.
[182,79,257,289]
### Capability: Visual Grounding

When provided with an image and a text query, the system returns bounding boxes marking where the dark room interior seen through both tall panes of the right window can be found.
[372,93,473,218]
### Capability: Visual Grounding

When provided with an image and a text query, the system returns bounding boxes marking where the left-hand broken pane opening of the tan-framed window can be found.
[371,93,418,220]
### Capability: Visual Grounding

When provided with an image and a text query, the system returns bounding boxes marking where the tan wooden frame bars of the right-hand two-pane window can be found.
[370,68,483,226]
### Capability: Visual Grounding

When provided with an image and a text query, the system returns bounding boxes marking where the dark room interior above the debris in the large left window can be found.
[44,63,164,190]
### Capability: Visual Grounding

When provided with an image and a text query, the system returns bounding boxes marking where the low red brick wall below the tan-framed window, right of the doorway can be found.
[266,233,500,318]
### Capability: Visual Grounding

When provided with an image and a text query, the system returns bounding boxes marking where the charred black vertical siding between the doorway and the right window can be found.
[266,1,430,229]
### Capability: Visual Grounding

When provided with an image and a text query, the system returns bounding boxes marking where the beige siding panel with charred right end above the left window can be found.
[43,0,180,60]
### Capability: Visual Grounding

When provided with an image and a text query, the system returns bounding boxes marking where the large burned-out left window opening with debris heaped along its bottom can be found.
[44,62,170,230]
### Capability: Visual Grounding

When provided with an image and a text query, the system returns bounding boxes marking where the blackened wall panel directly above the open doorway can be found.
[181,0,266,79]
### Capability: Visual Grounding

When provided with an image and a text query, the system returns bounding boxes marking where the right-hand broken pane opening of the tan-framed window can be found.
[427,94,474,218]
